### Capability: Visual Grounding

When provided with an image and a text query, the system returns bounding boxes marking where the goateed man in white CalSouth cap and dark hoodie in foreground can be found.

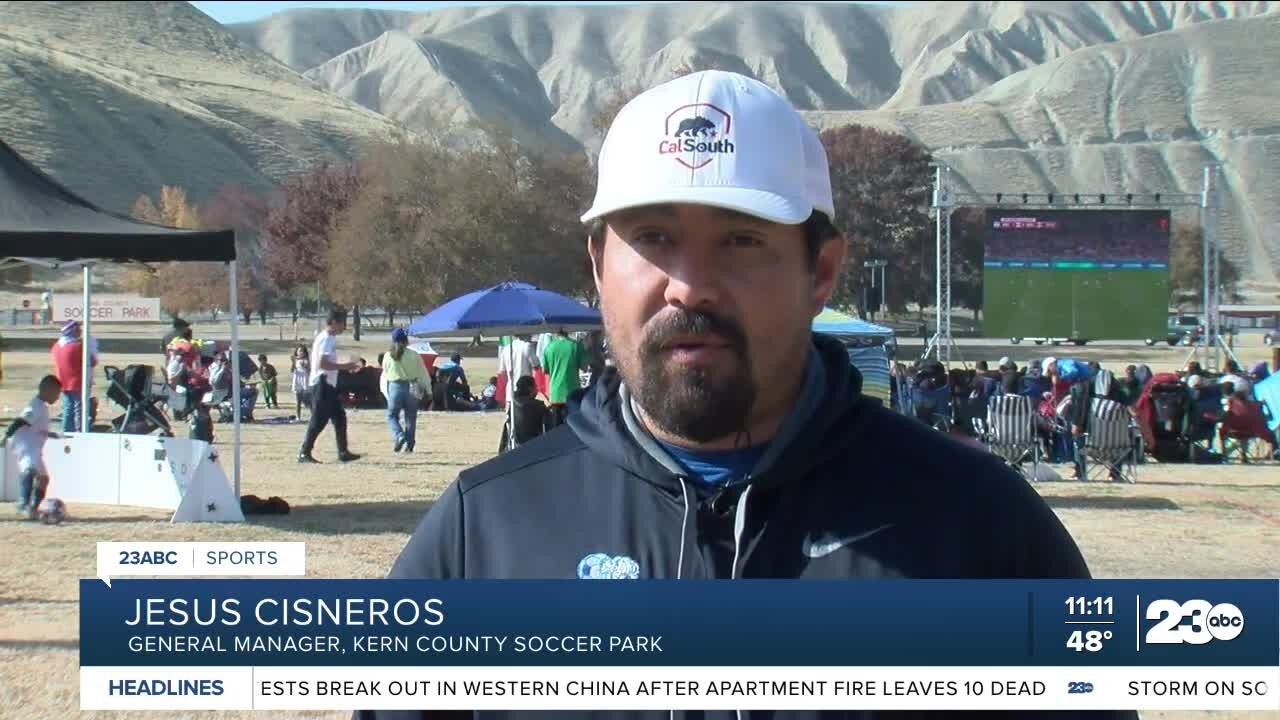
[373,70,1121,719]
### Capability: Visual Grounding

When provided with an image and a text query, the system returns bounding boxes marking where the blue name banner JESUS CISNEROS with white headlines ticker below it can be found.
[81,579,1280,711]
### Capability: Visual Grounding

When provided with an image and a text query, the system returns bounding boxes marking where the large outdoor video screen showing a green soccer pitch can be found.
[983,209,1170,340]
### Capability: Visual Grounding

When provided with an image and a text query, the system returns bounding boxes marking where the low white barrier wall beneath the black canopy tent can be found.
[0,433,244,523]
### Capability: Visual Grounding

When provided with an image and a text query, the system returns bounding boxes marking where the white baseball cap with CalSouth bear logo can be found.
[582,70,836,224]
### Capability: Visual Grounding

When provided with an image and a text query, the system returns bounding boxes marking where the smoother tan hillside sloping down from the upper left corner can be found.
[0,3,398,210]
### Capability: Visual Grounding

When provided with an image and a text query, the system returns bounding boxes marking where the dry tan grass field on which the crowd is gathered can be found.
[0,340,1280,720]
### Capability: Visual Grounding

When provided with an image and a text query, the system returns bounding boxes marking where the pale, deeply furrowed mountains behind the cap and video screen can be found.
[232,3,1280,291]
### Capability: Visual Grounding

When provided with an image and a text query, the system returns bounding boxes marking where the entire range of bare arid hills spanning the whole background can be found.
[0,3,1280,295]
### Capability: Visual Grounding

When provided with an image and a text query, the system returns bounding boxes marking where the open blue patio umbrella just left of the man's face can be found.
[406,282,600,337]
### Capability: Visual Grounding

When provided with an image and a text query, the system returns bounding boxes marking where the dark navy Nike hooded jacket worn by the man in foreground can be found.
[355,334,1135,720]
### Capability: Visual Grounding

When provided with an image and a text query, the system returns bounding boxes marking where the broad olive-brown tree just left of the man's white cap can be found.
[325,129,593,319]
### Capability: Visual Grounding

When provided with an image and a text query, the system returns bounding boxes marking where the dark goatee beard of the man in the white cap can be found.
[618,304,755,442]
